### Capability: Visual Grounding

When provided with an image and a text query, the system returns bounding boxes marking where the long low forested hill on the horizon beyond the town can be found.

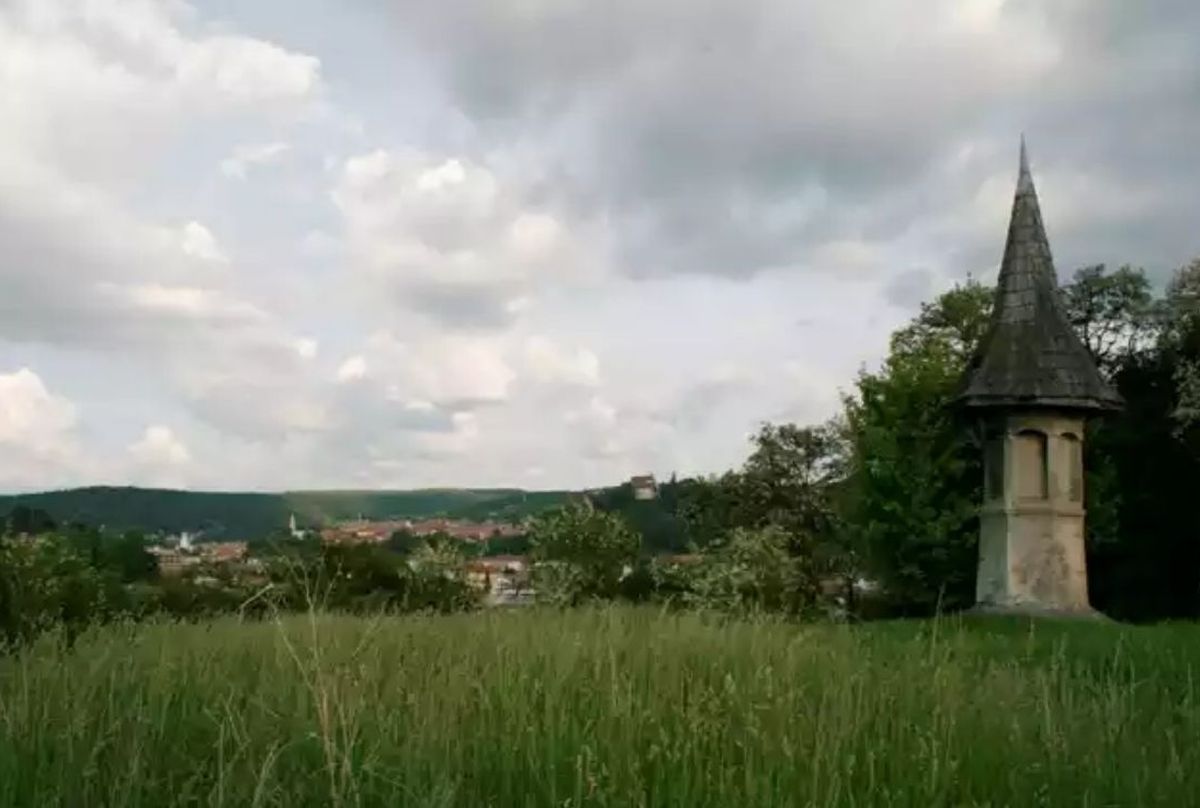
[0,486,569,539]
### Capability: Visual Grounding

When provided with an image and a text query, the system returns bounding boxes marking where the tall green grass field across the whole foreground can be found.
[0,609,1200,808]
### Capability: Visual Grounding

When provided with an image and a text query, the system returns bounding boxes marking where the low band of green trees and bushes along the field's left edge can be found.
[0,516,479,652]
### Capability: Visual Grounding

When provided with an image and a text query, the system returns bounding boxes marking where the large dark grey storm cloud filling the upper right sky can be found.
[381,0,1200,283]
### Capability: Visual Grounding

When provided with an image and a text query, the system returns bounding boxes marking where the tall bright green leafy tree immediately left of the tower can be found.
[845,282,992,614]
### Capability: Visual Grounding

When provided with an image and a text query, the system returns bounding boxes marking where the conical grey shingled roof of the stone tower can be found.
[958,138,1122,409]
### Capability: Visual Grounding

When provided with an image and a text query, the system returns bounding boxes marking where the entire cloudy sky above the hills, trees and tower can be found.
[0,0,1200,490]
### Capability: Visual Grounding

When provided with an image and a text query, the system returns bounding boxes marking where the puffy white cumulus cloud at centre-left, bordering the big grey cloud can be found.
[334,150,595,327]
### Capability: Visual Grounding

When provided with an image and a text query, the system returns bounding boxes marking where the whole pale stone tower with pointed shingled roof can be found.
[959,138,1122,614]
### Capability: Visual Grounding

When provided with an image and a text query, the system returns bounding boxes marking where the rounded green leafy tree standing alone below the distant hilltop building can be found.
[529,501,641,605]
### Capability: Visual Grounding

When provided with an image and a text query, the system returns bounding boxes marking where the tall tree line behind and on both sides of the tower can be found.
[534,261,1200,621]
